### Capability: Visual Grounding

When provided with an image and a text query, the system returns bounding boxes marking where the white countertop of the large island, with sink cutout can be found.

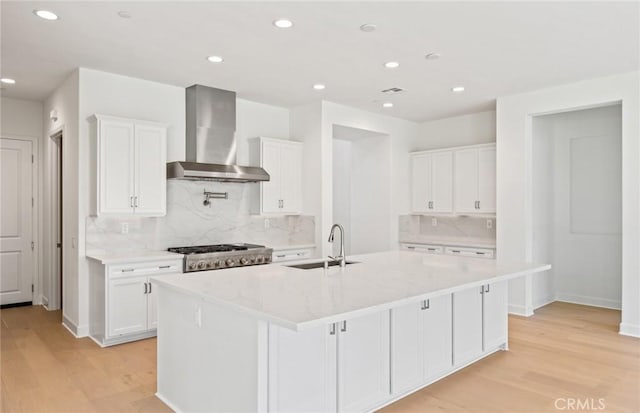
[152,251,551,331]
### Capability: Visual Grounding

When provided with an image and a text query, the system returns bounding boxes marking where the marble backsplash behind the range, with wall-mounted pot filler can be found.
[86,180,315,252]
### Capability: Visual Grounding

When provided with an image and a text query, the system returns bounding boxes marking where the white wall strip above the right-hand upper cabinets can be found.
[409,111,496,152]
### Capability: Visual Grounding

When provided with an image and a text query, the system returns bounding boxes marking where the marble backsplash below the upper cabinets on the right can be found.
[398,215,496,248]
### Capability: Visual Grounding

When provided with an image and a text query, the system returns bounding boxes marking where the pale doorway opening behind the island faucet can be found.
[332,125,391,256]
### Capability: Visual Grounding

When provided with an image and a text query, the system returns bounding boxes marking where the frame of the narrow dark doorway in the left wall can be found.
[44,125,65,311]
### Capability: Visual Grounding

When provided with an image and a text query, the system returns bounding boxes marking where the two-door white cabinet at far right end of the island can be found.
[453,281,507,366]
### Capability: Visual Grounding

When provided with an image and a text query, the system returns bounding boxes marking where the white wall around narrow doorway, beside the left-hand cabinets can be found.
[43,70,84,326]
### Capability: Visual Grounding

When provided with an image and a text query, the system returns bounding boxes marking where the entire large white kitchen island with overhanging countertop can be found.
[152,251,550,412]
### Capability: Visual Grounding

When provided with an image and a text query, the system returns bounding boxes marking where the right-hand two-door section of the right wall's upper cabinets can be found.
[454,145,496,213]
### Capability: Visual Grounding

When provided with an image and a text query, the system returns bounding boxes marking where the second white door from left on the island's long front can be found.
[338,311,390,412]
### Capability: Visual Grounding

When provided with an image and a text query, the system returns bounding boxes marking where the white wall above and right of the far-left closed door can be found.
[0,97,48,304]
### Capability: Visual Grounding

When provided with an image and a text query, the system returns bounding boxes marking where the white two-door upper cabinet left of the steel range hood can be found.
[91,115,167,216]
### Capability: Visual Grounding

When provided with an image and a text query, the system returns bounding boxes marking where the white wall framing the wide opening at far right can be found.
[496,72,640,336]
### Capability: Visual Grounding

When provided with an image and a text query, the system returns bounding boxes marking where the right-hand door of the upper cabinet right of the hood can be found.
[280,143,302,213]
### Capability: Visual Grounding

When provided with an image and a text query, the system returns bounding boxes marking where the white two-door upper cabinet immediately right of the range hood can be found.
[249,137,302,215]
